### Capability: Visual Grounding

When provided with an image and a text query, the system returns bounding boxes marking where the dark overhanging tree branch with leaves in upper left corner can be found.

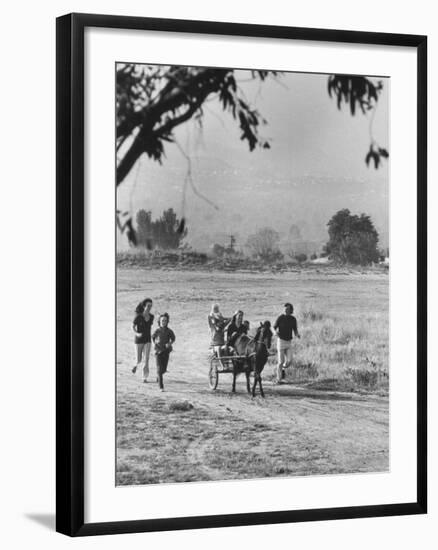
[117,65,277,185]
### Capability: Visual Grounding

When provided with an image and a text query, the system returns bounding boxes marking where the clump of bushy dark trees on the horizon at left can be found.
[136,208,187,250]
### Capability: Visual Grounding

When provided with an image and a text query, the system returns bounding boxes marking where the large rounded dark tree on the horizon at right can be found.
[325,208,379,265]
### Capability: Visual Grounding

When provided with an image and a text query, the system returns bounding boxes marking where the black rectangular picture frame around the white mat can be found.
[56,14,427,536]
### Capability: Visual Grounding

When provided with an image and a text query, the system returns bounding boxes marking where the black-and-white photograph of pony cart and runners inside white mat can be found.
[114,63,390,486]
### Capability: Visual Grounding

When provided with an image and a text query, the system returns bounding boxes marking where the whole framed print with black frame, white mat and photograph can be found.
[57,14,427,536]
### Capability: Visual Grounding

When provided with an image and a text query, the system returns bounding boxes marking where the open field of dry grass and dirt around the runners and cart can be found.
[117,268,389,485]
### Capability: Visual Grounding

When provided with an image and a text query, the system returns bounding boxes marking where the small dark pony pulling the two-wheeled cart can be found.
[232,321,272,397]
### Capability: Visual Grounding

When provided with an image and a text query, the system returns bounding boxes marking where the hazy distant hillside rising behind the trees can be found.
[118,162,389,252]
